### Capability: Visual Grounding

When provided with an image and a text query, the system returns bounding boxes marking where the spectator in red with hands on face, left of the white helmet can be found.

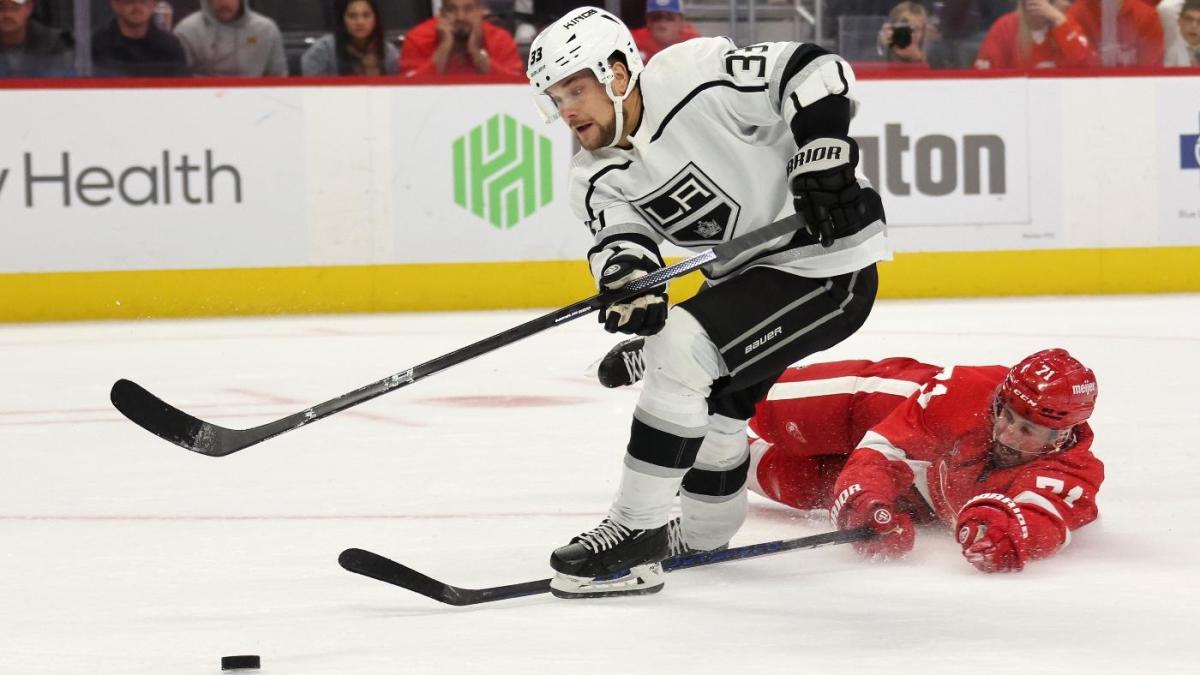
[400,0,524,77]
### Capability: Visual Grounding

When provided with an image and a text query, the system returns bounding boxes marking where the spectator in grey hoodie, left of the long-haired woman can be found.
[175,0,288,77]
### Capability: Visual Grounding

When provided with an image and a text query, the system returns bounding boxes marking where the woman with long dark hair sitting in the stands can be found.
[300,0,400,76]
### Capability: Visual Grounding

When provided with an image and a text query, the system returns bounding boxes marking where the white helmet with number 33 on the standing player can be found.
[526,7,644,147]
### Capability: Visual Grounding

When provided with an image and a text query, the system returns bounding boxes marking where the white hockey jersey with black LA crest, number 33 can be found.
[571,37,890,282]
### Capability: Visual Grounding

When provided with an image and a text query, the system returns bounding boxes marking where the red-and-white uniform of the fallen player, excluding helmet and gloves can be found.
[751,359,1104,558]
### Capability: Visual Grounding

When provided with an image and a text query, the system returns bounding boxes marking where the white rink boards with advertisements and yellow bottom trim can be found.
[0,74,1200,321]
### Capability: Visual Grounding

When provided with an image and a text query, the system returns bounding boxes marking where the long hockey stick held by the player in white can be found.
[109,216,804,458]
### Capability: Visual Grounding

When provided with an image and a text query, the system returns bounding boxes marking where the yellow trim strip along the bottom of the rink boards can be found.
[0,246,1200,322]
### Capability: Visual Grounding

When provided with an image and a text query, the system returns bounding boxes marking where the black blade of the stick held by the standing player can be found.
[108,380,241,456]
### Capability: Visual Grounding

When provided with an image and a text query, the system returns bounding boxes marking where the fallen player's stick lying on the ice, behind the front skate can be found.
[337,526,875,607]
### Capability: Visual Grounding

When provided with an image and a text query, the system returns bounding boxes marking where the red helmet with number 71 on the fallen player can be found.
[996,350,1097,429]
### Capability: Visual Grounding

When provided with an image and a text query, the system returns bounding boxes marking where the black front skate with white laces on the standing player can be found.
[550,518,668,598]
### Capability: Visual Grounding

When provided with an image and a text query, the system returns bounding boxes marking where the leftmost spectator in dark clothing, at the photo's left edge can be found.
[0,0,74,77]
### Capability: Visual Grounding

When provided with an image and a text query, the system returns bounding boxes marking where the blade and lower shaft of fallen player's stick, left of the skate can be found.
[337,549,550,607]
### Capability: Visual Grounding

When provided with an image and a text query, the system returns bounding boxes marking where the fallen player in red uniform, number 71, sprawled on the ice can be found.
[750,350,1104,572]
